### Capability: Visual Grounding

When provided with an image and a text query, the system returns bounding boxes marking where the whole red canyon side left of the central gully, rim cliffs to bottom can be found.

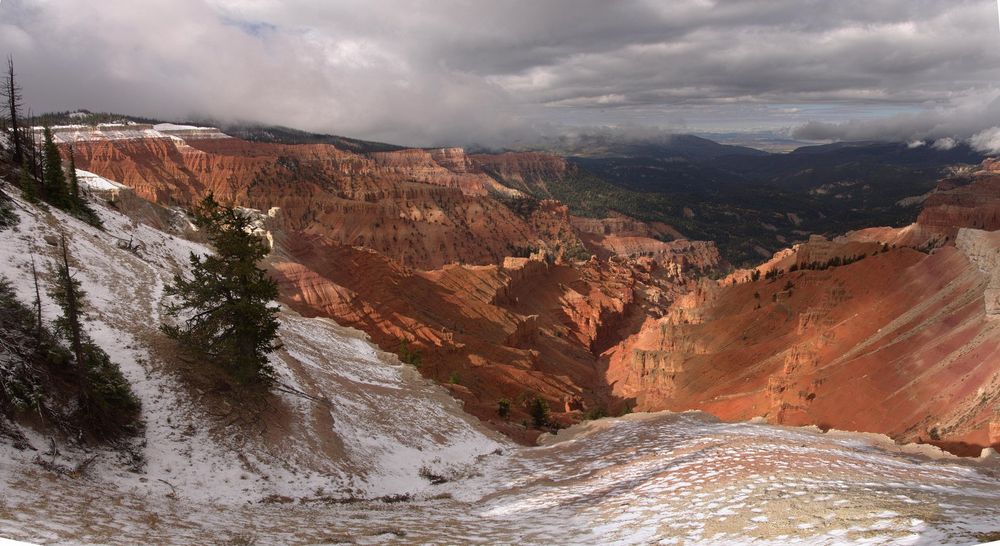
[56,125,719,438]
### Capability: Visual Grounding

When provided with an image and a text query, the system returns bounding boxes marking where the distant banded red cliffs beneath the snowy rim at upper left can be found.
[64,133,575,268]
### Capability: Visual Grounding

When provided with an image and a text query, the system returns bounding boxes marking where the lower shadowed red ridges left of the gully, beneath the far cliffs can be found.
[273,234,688,429]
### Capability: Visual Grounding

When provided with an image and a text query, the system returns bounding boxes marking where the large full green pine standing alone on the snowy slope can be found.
[163,195,279,385]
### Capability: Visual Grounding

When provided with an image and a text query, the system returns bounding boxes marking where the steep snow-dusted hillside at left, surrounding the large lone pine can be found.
[0,181,504,503]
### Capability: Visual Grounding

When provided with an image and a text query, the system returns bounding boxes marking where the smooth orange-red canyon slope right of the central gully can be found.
[606,164,1000,455]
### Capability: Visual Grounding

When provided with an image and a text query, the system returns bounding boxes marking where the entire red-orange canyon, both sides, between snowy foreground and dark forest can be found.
[56,125,1000,454]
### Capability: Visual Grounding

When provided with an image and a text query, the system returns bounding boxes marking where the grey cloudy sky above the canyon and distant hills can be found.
[0,0,1000,149]
